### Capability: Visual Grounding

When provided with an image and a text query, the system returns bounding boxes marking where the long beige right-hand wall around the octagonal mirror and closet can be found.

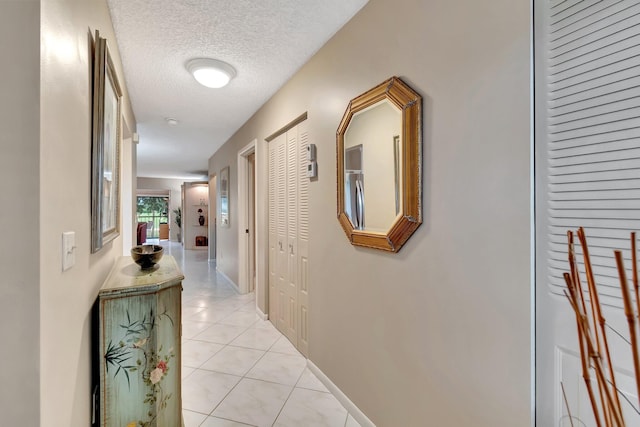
[209,0,532,427]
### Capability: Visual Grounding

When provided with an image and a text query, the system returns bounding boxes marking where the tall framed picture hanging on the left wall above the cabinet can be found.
[91,31,122,253]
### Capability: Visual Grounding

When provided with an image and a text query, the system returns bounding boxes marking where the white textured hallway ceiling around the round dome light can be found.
[107,0,367,179]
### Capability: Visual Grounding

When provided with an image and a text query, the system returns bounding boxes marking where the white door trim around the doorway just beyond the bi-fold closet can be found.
[238,139,258,294]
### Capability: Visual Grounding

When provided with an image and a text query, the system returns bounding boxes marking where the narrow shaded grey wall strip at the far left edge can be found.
[0,1,44,426]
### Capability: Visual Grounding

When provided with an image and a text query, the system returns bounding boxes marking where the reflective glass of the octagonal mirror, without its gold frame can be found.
[344,99,402,232]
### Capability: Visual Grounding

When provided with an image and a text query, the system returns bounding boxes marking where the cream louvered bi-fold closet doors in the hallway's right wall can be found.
[269,121,309,355]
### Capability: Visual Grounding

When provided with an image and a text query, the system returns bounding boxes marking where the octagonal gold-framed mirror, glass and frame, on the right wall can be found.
[336,77,422,252]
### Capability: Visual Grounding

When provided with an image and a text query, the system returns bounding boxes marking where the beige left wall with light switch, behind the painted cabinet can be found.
[36,0,136,427]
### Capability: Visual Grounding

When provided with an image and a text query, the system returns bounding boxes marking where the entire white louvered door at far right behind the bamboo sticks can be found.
[535,0,640,427]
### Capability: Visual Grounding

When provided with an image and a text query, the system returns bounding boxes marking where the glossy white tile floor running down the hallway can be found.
[156,241,359,427]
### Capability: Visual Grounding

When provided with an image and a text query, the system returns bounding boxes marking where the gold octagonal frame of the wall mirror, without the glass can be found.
[336,77,422,252]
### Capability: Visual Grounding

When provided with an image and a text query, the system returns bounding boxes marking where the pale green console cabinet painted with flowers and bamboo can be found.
[92,255,184,427]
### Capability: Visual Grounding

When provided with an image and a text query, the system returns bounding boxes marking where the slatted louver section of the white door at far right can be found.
[537,0,640,307]
